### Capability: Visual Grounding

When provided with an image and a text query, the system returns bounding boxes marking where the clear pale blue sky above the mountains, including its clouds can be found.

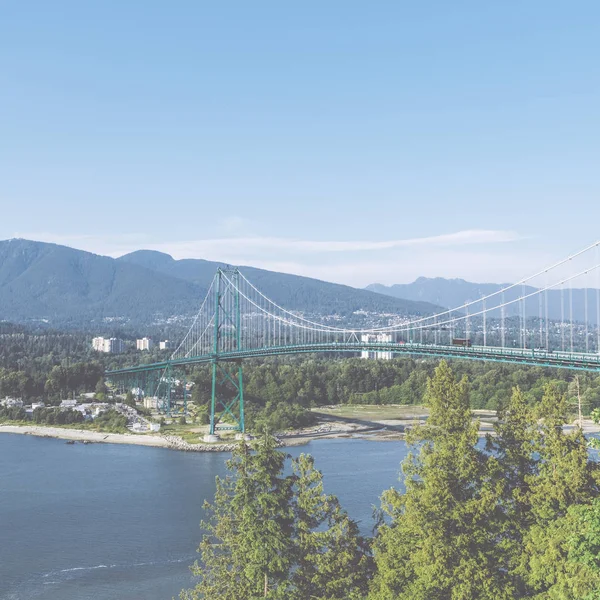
[0,0,600,286]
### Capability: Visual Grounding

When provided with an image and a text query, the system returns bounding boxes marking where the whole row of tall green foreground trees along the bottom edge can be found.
[181,362,600,600]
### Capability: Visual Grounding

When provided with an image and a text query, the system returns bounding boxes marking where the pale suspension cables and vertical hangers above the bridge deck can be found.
[166,242,600,358]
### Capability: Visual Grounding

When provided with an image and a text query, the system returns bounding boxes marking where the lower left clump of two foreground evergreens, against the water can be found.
[180,436,372,600]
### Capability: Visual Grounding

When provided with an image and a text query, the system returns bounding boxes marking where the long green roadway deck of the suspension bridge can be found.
[106,342,600,379]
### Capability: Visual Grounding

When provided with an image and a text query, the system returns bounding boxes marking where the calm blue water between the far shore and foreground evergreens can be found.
[0,434,406,600]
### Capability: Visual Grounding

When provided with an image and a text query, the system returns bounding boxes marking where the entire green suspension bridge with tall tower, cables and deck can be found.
[106,241,600,435]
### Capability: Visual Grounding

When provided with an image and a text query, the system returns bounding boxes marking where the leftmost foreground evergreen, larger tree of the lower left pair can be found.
[181,436,294,600]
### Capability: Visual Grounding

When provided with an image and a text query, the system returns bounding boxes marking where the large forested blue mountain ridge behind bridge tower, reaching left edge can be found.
[0,239,439,330]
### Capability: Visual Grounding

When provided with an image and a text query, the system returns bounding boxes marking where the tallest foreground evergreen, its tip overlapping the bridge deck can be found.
[370,362,514,600]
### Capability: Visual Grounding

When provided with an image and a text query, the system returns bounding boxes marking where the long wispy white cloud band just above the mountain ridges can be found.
[7,230,528,286]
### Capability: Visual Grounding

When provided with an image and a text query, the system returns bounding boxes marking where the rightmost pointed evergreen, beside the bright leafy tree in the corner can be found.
[516,385,600,600]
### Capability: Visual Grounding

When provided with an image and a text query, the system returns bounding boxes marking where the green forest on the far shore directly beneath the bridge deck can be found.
[191,357,600,431]
